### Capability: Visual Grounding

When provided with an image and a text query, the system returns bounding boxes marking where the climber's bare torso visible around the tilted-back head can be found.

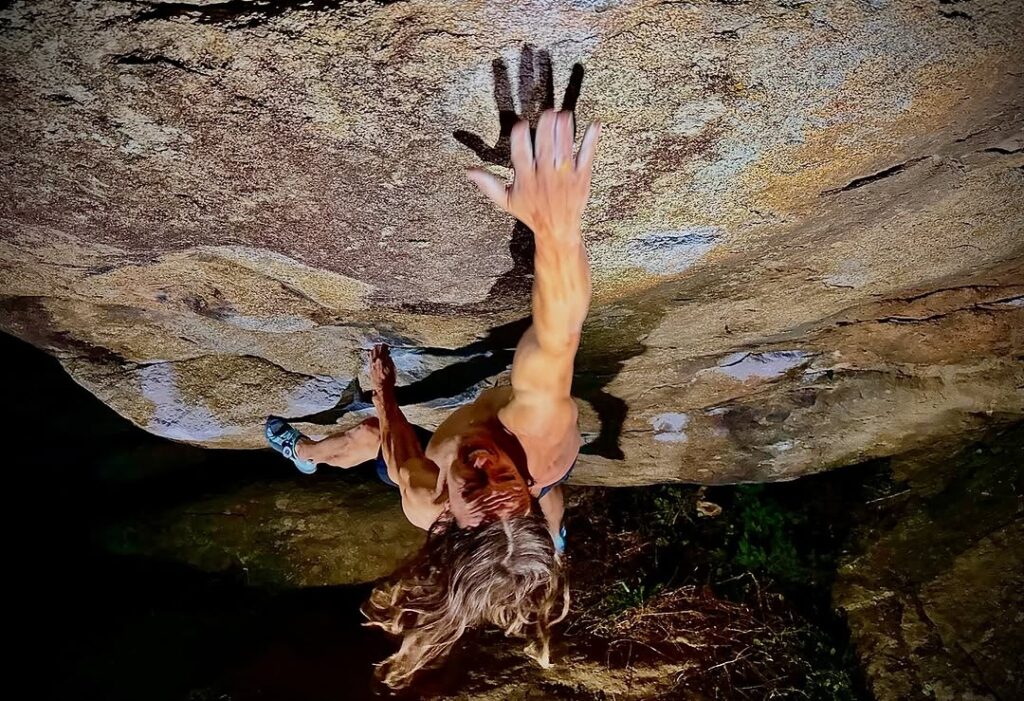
[426,386,581,496]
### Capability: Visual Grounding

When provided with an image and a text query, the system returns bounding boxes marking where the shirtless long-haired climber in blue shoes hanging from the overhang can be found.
[266,109,600,688]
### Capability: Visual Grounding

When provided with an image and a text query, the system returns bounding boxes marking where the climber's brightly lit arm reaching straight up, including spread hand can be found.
[469,109,600,454]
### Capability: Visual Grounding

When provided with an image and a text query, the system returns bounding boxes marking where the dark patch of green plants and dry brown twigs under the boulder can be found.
[570,466,887,701]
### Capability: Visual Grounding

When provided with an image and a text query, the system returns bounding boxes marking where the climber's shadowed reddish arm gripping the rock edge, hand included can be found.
[370,344,441,529]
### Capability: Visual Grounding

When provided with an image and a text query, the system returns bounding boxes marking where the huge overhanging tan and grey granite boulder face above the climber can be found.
[0,0,1024,484]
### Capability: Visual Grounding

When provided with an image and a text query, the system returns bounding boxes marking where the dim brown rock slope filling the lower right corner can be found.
[834,427,1024,701]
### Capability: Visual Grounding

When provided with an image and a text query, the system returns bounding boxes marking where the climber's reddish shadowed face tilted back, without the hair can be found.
[447,426,534,528]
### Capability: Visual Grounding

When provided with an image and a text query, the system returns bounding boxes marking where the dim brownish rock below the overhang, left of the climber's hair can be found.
[102,480,424,587]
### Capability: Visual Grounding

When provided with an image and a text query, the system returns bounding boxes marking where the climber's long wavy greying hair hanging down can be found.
[362,514,569,689]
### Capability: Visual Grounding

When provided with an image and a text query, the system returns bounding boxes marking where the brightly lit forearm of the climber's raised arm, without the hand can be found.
[532,229,591,352]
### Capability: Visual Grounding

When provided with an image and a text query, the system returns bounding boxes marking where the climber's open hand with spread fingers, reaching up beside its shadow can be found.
[468,109,601,236]
